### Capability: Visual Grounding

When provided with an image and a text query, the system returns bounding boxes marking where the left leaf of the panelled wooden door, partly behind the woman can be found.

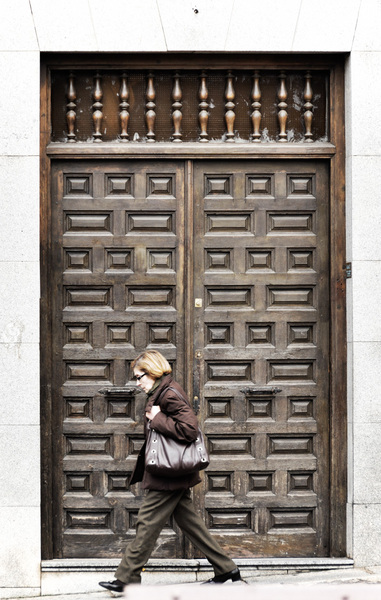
[52,160,184,557]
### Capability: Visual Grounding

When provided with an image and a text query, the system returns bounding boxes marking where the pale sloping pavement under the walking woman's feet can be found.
[0,566,381,600]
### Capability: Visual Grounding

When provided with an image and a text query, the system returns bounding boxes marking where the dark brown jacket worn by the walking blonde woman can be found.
[130,375,201,491]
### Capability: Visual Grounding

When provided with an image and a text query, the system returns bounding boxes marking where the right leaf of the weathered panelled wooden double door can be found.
[194,160,329,557]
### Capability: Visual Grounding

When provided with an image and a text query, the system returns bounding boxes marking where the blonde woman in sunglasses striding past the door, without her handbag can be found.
[99,351,241,592]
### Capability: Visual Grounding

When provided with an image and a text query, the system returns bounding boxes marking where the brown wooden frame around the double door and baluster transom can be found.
[40,54,347,559]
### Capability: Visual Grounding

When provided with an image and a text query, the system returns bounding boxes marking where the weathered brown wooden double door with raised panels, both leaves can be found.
[50,159,330,558]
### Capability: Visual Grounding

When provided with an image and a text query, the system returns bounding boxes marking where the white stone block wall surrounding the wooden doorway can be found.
[0,0,381,598]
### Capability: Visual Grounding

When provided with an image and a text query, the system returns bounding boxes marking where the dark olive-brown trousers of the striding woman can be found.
[115,489,236,583]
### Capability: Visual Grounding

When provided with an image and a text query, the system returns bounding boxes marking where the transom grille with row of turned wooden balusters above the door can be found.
[51,69,329,143]
